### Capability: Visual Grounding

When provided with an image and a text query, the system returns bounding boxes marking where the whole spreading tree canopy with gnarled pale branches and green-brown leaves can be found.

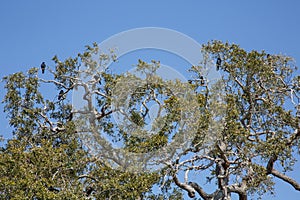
[0,41,300,199]
